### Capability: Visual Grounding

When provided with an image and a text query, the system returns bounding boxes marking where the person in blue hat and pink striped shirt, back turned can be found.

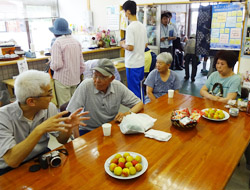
[49,18,84,106]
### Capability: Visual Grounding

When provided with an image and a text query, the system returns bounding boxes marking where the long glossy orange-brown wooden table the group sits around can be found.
[0,94,250,190]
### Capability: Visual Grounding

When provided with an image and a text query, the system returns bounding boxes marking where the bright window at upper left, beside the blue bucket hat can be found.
[0,0,58,51]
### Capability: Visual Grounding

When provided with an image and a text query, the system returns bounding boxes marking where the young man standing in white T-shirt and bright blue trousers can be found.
[120,1,148,100]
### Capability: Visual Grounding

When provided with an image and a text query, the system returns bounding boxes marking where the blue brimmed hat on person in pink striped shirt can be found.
[49,18,71,35]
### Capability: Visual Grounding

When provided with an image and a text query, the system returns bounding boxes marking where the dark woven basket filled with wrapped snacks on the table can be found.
[171,108,201,130]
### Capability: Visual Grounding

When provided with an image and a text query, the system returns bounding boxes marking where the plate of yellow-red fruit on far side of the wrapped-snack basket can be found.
[201,108,230,121]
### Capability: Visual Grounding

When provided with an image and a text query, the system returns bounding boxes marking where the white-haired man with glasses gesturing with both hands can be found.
[0,70,89,175]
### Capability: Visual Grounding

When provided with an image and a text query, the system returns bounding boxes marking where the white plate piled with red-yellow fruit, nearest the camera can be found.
[104,152,148,179]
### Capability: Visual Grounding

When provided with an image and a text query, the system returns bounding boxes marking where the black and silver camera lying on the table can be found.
[39,150,62,169]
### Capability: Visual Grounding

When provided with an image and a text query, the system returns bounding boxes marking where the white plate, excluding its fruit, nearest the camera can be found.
[104,152,148,179]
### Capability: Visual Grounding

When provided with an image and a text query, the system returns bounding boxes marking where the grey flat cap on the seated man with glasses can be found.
[92,59,115,77]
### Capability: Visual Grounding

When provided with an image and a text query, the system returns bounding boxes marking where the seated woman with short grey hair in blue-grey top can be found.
[144,52,181,104]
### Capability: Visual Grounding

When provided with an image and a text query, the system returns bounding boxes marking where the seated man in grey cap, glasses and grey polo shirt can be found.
[66,59,143,135]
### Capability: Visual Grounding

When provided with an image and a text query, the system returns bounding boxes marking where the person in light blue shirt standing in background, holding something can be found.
[160,13,176,56]
